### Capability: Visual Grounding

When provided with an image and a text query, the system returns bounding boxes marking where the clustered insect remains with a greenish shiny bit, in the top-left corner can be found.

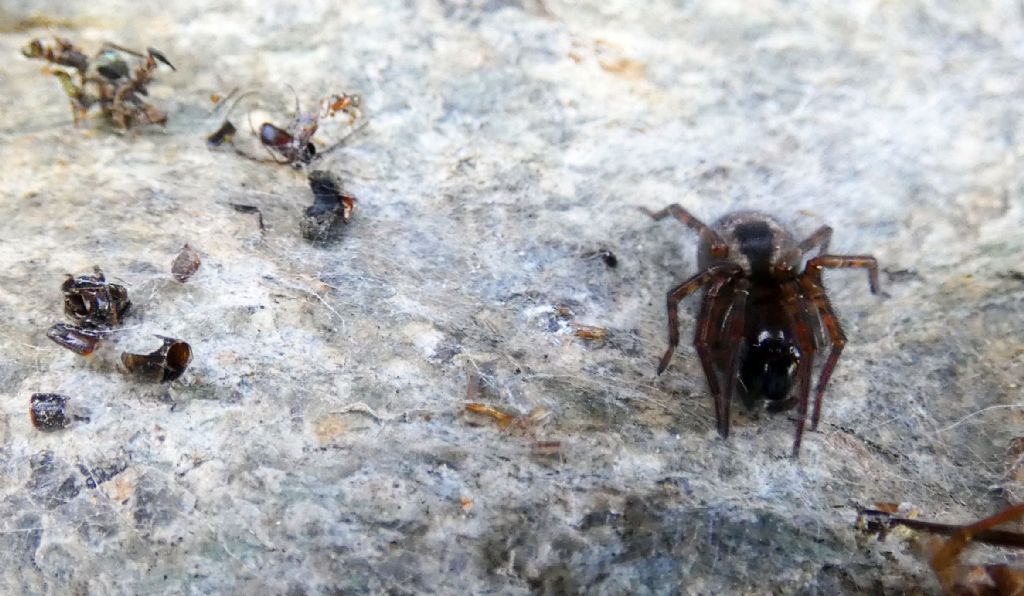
[22,38,175,130]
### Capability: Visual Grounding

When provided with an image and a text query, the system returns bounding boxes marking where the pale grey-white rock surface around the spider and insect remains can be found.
[0,0,1024,594]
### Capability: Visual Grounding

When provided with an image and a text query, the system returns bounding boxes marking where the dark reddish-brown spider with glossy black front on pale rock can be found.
[641,204,879,457]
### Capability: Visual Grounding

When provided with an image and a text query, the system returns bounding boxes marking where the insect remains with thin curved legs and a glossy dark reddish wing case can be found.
[206,91,365,168]
